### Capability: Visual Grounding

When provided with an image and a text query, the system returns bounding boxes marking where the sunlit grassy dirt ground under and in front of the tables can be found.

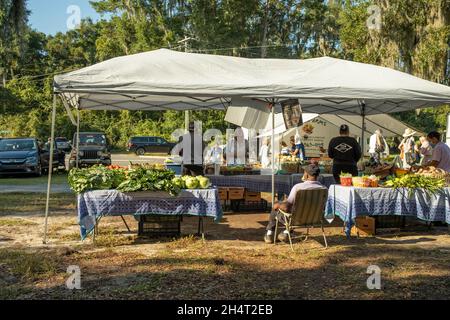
[0,194,450,300]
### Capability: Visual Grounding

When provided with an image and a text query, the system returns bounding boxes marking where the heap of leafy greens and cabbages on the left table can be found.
[69,164,210,196]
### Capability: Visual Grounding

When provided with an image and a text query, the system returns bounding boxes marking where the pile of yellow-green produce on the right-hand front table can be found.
[385,174,446,194]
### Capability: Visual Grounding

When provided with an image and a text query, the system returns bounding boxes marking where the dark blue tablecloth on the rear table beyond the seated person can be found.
[208,174,335,195]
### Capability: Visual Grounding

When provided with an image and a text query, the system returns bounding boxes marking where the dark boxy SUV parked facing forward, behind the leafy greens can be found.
[69,132,111,170]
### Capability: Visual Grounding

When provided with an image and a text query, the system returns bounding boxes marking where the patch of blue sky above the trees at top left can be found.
[28,0,108,34]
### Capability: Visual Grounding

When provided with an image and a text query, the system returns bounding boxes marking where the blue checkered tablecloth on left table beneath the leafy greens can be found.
[78,189,223,240]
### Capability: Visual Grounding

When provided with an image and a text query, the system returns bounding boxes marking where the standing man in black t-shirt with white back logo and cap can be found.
[328,124,362,183]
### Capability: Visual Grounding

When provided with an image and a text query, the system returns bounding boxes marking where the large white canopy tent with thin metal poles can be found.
[44,49,450,242]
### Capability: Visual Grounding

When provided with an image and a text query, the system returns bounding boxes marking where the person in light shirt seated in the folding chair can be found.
[264,164,326,243]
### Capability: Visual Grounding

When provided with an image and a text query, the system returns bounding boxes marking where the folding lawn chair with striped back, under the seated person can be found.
[275,188,328,251]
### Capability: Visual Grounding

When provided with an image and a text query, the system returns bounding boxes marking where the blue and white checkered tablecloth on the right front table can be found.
[326,185,450,233]
